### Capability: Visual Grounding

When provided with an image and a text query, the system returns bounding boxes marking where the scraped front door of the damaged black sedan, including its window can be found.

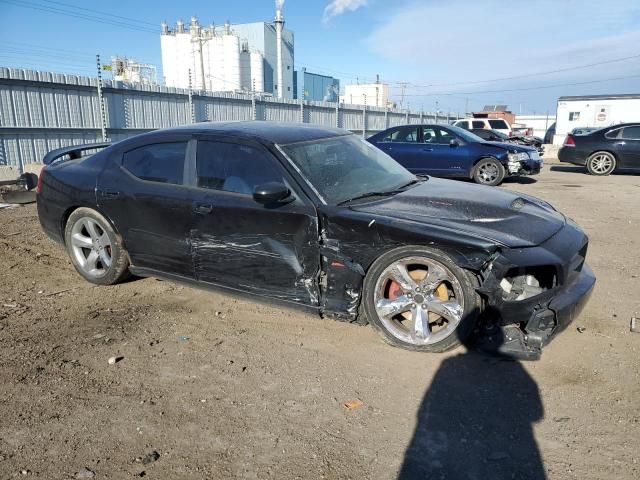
[191,136,320,306]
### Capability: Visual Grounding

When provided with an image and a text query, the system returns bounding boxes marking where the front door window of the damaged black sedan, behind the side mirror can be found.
[196,140,283,195]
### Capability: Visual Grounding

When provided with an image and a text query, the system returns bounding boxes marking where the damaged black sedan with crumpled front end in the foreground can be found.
[38,122,595,358]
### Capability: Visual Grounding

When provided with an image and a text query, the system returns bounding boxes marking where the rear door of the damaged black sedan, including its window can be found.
[96,135,195,277]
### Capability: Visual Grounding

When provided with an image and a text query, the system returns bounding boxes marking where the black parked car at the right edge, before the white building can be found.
[558,123,640,175]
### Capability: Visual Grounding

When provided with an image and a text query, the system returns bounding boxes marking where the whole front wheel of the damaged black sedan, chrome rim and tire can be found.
[362,246,480,352]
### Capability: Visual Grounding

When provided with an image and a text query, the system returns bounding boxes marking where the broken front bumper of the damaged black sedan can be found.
[475,221,596,360]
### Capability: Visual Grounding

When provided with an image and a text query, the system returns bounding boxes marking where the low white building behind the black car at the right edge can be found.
[553,95,640,145]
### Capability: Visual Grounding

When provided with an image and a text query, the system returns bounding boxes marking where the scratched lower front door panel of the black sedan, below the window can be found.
[190,192,320,306]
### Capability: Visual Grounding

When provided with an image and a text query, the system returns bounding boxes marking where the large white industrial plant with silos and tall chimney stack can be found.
[160,1,294,98]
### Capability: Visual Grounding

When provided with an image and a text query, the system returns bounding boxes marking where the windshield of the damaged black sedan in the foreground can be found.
[280,135,416,205]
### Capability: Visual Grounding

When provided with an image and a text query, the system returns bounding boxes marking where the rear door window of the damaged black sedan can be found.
[122,142,187,185]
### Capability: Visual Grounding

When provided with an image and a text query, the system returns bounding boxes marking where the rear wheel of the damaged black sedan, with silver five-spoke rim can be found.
[64,207,130,285]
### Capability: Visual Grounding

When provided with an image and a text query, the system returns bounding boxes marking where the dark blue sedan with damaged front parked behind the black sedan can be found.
[368,125,542,185]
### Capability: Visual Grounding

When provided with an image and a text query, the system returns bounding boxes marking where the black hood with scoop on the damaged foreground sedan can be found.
[352,178,565,248]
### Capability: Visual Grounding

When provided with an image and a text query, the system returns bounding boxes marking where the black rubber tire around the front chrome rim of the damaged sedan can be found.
[361,246,481,352]
